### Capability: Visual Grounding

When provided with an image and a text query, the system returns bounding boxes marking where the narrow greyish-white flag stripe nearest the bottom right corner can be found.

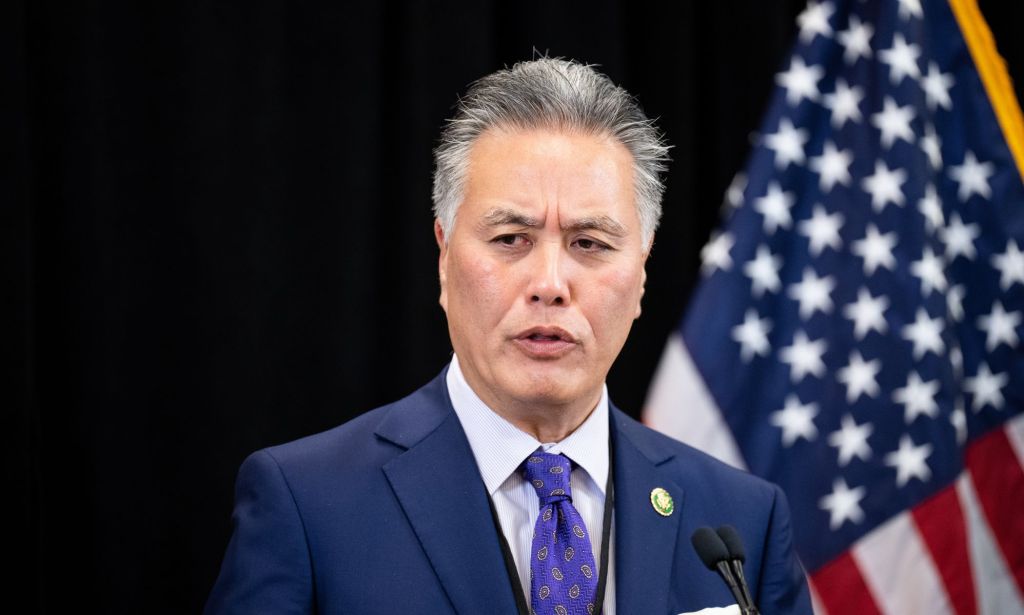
[956,472,1024,615]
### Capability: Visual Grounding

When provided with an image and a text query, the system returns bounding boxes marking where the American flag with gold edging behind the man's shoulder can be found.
[645,0,1024,615]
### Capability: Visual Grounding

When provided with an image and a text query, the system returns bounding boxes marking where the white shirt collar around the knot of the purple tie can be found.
[445,355,609,495]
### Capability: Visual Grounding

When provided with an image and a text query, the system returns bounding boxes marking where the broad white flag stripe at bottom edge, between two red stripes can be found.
[852,513,952,615]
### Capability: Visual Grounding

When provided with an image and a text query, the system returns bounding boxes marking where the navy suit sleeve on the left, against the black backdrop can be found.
[204,450,313,615]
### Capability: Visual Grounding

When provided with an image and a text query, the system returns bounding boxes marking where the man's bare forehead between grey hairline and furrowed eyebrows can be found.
[463,129,638,225]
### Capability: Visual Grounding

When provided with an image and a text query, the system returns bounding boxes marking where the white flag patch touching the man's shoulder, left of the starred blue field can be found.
[644,332,746,470]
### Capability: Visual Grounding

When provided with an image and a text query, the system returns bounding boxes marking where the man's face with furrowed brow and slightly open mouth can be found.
[435,130,649,412]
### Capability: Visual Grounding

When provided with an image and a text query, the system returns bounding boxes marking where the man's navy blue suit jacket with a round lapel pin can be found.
[206,366,811,615]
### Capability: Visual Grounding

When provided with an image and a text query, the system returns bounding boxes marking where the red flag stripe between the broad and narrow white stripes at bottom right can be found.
[911,485,978,615]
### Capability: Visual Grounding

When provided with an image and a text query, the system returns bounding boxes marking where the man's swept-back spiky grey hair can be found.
[433,57,669,244]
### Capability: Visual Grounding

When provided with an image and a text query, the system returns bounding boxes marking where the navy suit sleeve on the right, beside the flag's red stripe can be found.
[755,485,813,615]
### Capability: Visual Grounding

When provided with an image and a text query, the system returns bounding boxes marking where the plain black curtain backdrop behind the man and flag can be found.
[8,0,1024,613]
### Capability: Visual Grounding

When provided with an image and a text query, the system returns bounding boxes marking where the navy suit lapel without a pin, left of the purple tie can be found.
[378,372,516,613]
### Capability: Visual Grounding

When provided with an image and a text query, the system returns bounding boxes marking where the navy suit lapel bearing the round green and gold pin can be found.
[611,410,684,613]
